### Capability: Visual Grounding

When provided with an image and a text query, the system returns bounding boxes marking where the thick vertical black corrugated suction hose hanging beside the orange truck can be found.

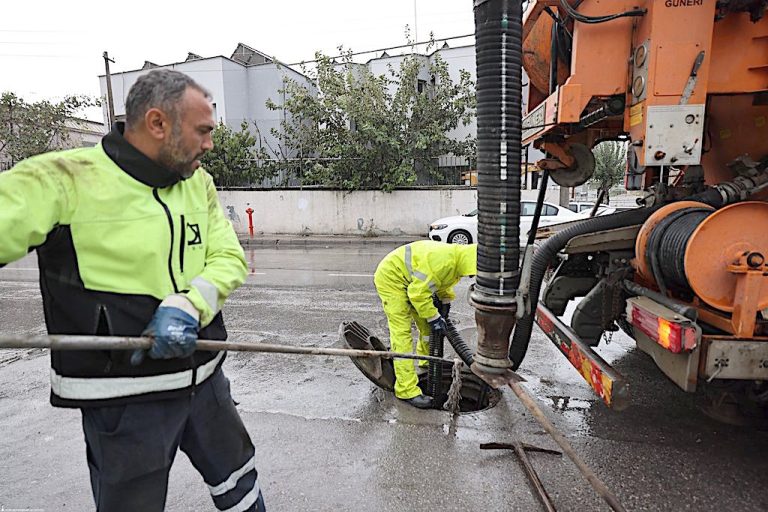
[474,0,522,298]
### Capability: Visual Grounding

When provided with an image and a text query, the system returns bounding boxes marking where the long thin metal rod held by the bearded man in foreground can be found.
[0,335,450,363]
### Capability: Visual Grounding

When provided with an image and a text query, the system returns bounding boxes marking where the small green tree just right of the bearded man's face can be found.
[201,121,275,187]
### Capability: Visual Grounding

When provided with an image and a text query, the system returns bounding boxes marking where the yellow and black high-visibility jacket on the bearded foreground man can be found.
[0,128,247,406]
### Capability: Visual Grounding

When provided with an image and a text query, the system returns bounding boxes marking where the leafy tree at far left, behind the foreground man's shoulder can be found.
[0,92,99,163]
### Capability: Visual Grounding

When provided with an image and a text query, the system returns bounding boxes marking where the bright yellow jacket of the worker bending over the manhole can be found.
[374,240,477,321]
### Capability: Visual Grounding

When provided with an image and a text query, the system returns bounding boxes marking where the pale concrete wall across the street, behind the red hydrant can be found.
[219,188,557,236]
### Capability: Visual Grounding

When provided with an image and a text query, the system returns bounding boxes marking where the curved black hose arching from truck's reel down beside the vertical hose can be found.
[509,207,659,370]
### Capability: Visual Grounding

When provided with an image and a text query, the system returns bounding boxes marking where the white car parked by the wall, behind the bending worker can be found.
[429,201,586,247]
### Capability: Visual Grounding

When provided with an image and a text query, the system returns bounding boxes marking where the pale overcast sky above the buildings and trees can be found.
[0,0,474,117]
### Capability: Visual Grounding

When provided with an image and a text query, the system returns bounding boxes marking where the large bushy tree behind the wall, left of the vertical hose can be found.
[267,40,475,191]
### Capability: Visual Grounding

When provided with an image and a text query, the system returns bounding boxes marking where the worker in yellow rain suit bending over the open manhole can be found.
[373,240,477,409]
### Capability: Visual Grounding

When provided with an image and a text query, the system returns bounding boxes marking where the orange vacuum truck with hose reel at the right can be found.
[509,0,768,422]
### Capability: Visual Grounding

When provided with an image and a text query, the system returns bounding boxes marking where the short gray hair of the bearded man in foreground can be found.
[125,69,211,127]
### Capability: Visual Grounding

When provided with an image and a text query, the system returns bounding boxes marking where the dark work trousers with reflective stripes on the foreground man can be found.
[82,369,265,512]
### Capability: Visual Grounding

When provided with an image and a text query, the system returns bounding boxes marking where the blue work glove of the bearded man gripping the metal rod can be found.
[131,295,200,366]
